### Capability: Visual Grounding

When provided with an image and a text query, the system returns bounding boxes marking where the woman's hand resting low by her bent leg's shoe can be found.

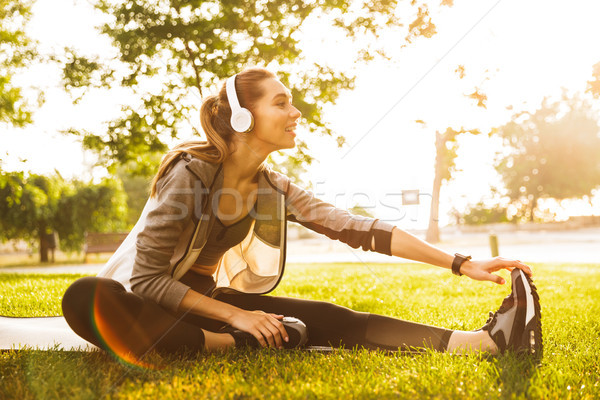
[230,309,290,348]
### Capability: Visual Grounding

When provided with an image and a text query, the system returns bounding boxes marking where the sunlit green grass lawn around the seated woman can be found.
[0,264,600,399]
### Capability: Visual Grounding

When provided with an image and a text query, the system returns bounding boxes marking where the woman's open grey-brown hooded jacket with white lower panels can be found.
[98,153,394,311]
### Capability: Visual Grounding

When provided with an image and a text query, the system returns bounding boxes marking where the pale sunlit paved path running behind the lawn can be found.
[0,228,600,274]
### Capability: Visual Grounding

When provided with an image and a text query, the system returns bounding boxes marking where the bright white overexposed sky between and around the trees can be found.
[0,0,600,228]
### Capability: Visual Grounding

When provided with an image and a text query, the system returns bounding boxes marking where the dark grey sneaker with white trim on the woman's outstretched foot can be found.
[481,268,543,358]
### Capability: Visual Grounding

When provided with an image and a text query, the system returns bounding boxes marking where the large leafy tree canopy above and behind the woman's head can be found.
[59,0,451,175]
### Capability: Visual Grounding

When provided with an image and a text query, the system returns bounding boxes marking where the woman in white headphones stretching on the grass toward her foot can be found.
[63,68,541,358]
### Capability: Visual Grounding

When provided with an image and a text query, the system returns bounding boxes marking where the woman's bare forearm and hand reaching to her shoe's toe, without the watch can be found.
[391,227,532,284]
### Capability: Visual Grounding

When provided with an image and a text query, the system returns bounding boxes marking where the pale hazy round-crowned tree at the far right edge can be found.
[496,94,600,221]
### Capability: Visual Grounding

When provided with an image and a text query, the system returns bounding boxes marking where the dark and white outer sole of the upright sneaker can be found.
[518,270,544,359]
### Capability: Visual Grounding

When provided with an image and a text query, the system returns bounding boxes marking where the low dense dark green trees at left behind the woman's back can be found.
[0,169,126,262]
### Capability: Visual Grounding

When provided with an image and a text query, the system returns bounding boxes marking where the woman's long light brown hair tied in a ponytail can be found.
[150,67,276,197]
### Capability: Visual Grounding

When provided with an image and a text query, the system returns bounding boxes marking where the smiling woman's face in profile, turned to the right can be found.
[248,78,302,152]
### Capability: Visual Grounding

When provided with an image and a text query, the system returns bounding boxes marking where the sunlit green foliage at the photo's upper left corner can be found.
[0,0,37,126]
